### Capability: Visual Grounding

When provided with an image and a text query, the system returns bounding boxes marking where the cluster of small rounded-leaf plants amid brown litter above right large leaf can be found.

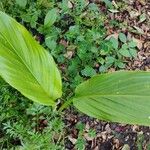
[99,33,137,72]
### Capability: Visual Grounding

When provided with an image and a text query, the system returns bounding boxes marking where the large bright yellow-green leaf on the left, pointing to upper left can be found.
[0,12,62,105]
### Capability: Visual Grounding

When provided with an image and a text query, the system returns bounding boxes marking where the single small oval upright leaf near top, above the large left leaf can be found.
[44,8,58,27]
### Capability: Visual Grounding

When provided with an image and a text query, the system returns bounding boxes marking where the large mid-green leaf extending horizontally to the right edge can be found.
[73,71,150,126]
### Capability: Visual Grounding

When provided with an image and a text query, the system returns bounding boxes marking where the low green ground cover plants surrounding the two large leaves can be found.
[0,0,148,149]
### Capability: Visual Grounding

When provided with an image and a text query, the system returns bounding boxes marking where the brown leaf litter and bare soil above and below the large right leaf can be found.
[64,0,150,150]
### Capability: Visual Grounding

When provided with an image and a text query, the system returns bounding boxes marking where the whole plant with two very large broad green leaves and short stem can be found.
[0,12,150,130]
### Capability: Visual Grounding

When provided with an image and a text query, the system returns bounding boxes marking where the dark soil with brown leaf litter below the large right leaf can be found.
[64,109,150,150]
